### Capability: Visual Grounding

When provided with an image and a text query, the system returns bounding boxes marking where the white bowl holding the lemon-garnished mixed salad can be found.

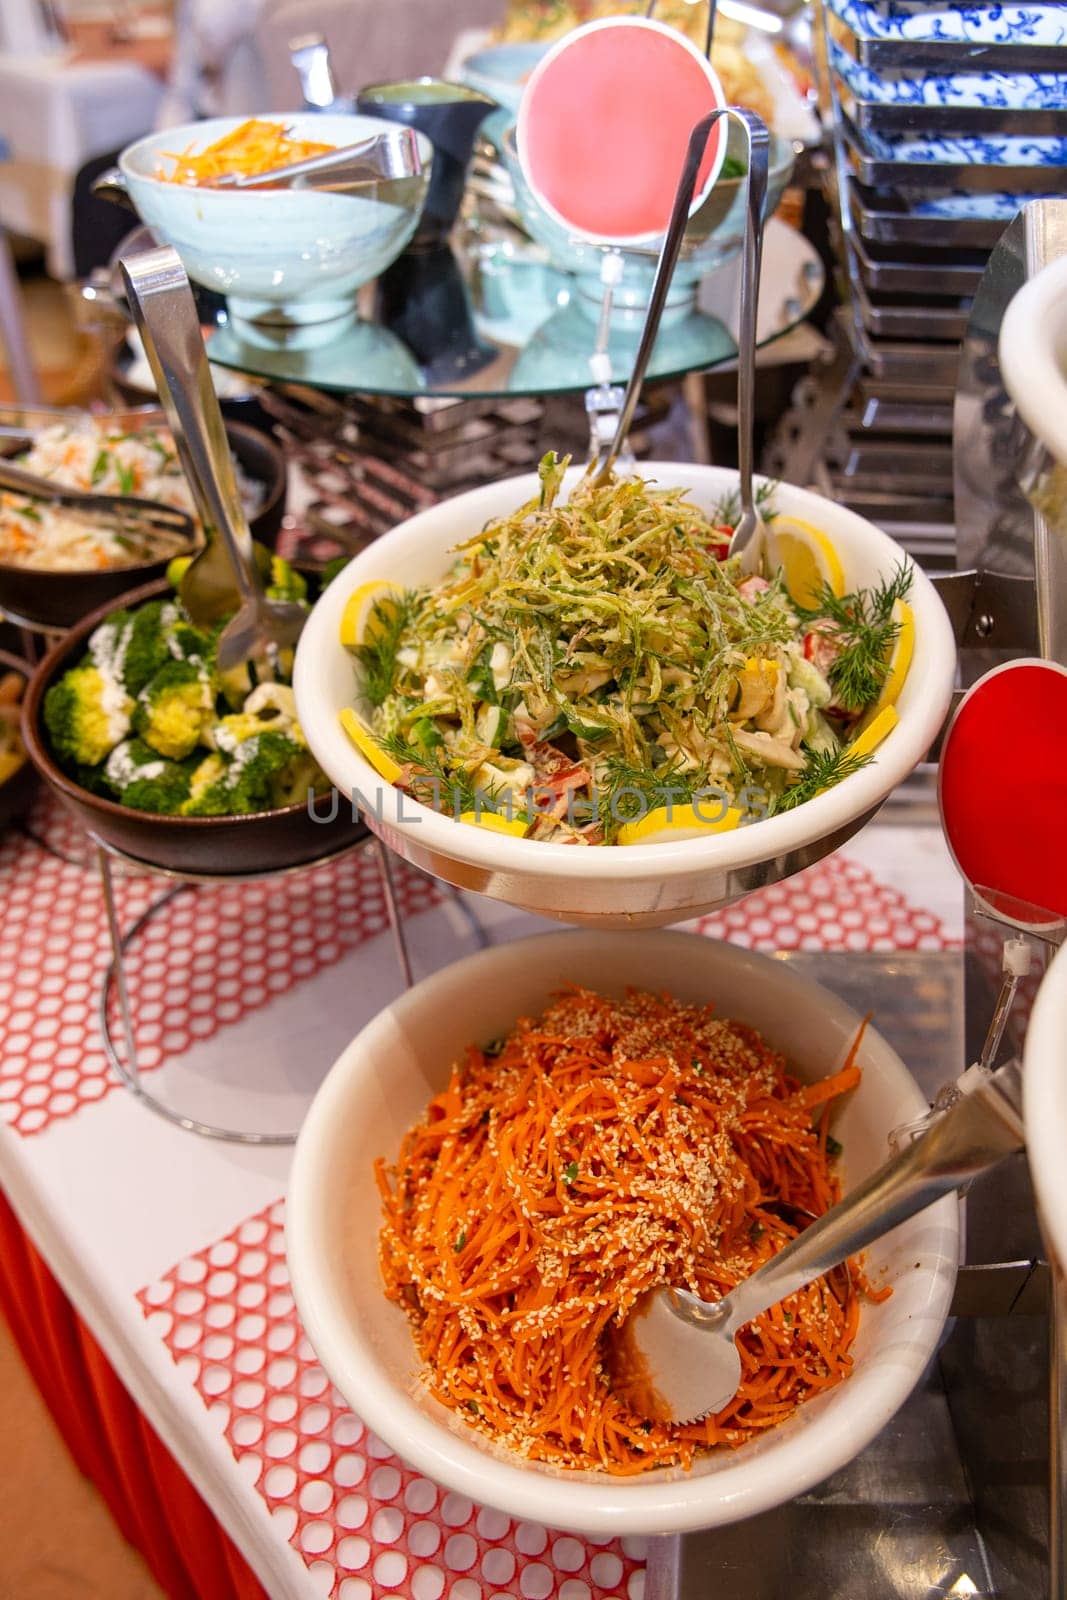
[293,462,955,928]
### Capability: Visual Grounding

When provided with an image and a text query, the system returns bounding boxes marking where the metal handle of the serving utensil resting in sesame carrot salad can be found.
[675,1061,1025,1334]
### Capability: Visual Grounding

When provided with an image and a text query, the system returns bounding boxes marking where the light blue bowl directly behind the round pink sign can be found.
[502,125,793,326]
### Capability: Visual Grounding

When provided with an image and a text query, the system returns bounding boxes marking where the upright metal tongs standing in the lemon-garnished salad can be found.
[585,106,771,573]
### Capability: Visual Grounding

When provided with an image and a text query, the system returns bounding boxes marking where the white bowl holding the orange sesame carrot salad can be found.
[286,931,958,1534]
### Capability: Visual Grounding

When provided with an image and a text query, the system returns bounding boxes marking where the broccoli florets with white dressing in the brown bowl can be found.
[43,549,326,816]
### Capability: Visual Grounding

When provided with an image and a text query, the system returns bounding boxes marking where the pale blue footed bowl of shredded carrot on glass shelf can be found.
[118,112,432,328]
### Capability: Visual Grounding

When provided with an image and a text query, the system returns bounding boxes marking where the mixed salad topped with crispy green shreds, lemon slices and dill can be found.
[342,454,913,845]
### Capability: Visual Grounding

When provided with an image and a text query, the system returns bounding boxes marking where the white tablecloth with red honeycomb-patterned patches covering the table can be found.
[0,790,961,1600]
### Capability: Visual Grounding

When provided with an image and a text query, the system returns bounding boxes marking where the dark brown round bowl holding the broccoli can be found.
[22,582,368,878]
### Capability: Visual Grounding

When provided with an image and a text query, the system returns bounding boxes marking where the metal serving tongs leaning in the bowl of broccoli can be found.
[120,245,307,672]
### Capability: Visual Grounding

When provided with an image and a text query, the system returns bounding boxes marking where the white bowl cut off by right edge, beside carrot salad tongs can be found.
[1022,946,1067,1272]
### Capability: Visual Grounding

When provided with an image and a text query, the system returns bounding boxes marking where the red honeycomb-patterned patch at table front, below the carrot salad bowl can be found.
[138,1200,645,1600]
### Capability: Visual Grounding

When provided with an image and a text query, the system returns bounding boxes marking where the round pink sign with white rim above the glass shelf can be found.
[517,18,726,245]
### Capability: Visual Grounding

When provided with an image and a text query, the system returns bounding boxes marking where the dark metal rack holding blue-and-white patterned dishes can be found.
[817,0,1067,558]
